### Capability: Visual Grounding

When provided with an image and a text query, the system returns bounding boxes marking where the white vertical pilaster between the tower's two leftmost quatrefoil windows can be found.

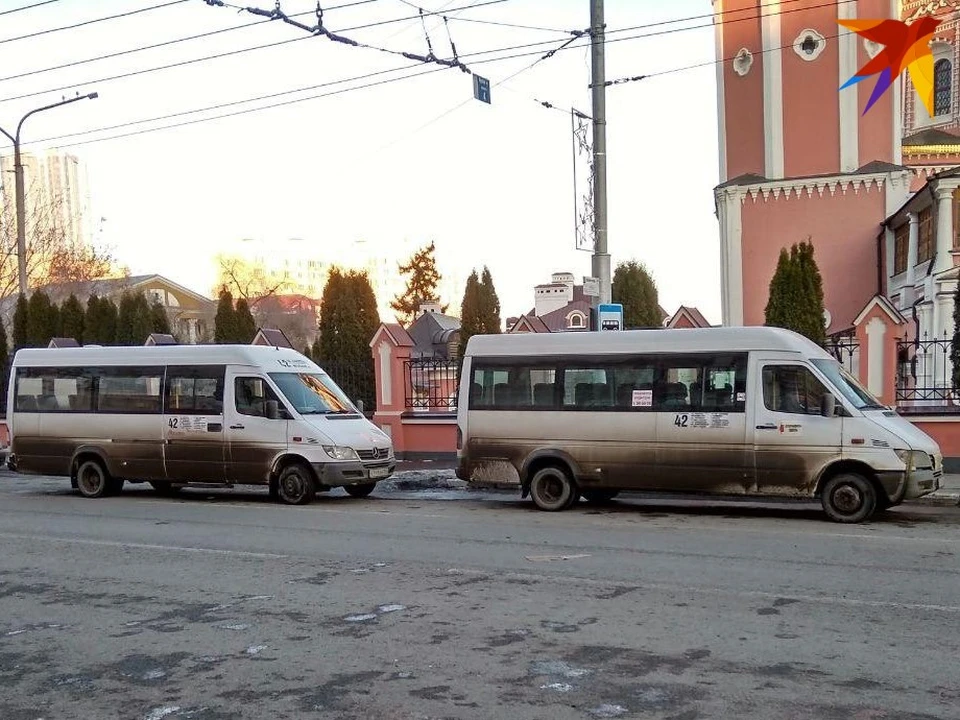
[760,0,784,180]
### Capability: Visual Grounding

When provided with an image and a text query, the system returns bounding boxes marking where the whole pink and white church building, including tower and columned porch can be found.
[713,0,960,457]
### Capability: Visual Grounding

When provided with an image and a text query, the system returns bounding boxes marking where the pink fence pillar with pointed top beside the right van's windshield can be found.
[854,295,907,406]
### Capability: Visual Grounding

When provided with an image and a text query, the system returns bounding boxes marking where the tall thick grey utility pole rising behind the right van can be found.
[590,0,611,304]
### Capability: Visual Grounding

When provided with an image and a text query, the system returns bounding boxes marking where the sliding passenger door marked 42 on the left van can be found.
[163,365,227,483]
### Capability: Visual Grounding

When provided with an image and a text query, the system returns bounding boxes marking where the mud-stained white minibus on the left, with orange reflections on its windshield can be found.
[7,345,396,504]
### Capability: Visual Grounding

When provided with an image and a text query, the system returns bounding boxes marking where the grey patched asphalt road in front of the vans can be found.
[0,475,960,720]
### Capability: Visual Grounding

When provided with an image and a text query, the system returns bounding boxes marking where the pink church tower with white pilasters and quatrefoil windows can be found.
[713,0,910,332]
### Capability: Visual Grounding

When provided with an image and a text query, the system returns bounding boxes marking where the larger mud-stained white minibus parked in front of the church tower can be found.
[457,327,943,522]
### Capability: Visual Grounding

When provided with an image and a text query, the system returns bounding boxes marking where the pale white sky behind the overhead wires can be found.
[0,0,720,323]
